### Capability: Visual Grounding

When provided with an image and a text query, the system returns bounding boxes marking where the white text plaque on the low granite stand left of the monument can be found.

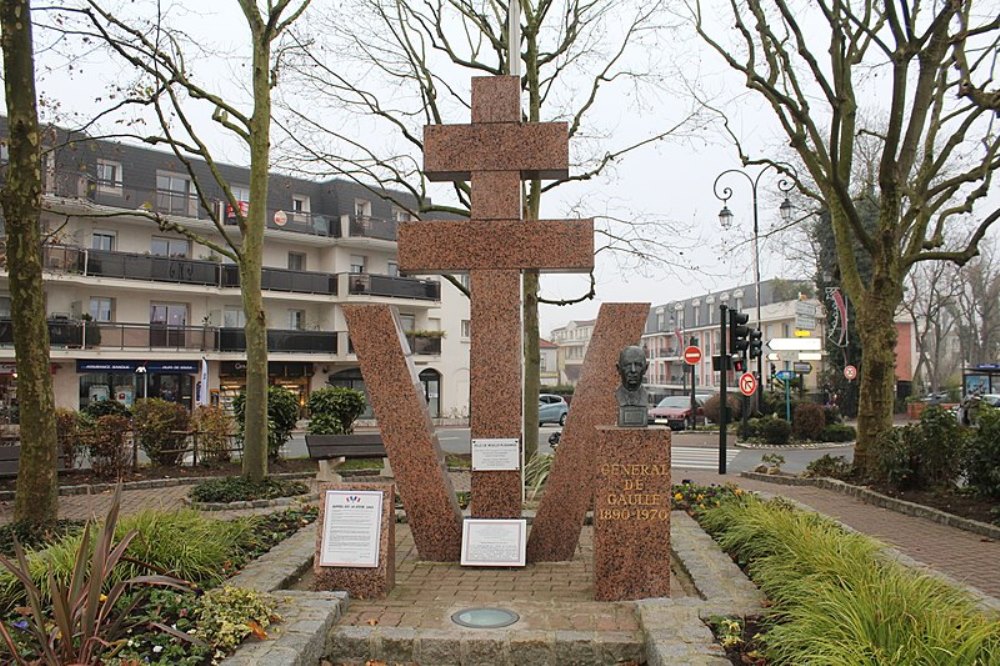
[319,490,382,568]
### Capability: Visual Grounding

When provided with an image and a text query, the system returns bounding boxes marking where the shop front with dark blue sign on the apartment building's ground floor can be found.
[76,359,201,409]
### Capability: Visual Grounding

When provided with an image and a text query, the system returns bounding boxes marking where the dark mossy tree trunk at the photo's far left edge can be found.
[0,0,59,525]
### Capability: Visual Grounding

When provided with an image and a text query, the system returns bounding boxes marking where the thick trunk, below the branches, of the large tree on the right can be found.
[854,276,902,475]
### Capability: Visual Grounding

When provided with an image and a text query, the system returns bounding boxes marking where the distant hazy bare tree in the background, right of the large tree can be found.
[902,261,960,393]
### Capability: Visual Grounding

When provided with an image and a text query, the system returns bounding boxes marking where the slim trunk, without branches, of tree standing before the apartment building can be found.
[240,23,271,480]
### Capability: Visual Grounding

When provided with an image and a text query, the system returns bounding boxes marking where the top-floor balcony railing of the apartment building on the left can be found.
[45,170,340,237]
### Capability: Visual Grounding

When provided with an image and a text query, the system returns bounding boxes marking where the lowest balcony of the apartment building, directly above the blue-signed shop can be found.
[0,319,217,352]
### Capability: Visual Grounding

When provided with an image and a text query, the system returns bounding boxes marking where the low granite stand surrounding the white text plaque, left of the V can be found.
[313,482,396,599]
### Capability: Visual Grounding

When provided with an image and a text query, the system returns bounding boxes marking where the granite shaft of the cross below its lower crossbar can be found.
[469,270,522,518]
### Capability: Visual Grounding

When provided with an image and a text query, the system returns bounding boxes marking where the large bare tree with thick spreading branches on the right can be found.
[687,0,1000,471]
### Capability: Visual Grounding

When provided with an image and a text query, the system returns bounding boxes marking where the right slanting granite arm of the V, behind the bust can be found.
[527,303,649,562]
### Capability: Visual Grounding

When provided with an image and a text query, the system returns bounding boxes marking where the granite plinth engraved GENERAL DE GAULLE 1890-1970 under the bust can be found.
[594,427,670,601]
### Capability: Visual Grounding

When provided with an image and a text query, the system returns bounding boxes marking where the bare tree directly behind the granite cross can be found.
[288,0,694,456]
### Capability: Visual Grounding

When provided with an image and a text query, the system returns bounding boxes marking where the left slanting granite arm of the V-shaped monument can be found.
[342,304,462,562]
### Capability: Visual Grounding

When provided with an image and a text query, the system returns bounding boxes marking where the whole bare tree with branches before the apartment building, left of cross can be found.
[63,0,311,480]
